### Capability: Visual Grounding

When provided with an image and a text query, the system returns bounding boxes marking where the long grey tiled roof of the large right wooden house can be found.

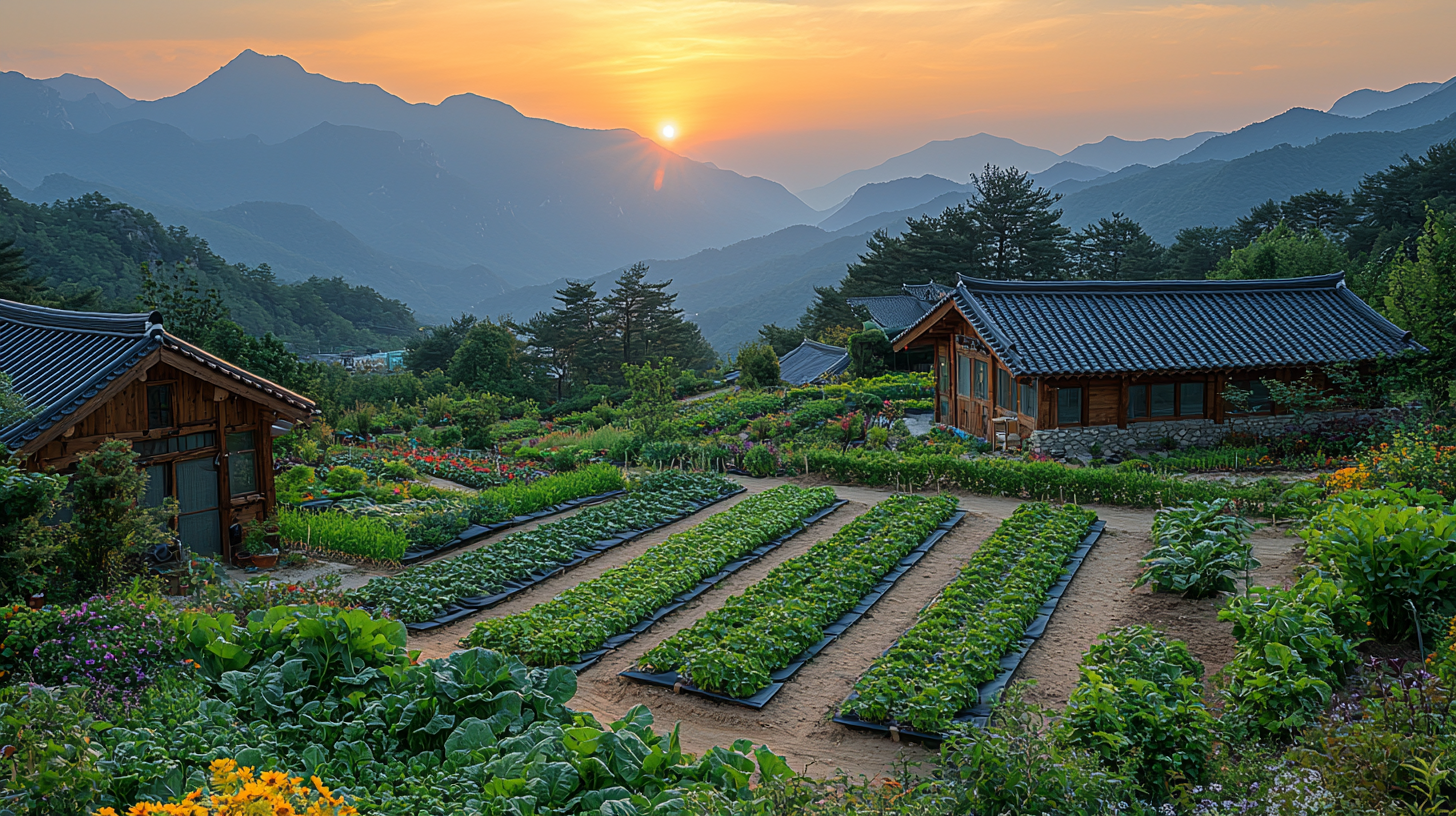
[901,274,1421,376]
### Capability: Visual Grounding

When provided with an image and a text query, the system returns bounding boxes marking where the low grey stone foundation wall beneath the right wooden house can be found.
[1025,411,1383,456]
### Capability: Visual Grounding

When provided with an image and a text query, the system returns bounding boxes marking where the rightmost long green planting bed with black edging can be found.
[834,503,1102,742]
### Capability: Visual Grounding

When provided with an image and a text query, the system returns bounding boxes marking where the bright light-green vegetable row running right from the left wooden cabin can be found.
[278,465,622,561]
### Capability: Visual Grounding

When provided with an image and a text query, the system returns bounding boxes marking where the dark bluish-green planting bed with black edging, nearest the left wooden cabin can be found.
[355,471,743,631]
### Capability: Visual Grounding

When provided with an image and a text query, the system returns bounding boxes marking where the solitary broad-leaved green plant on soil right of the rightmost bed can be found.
[1133,500,1259,600]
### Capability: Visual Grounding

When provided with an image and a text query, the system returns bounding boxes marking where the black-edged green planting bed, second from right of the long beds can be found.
[622,495,965,708]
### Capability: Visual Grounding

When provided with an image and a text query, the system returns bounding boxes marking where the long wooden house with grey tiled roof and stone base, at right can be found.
[885,274,1423,455]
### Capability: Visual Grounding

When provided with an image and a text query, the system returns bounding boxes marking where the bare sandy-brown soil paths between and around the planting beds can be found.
[396,478,1299,778]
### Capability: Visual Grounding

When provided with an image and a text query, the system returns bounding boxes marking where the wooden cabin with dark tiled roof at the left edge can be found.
[0,300,316,557]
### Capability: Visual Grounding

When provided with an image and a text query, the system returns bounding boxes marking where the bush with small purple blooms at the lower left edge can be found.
[6,584,181,705]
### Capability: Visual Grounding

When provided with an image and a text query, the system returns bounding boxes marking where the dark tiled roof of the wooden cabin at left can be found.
[0,300,316,449]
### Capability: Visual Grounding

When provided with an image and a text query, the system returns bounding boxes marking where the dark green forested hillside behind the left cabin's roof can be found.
[0,187,416,351]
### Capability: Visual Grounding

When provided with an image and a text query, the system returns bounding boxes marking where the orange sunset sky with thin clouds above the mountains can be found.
[0,0,1456,189]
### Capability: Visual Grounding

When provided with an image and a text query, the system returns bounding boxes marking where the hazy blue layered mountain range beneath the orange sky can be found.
[0,51,1456,351]
